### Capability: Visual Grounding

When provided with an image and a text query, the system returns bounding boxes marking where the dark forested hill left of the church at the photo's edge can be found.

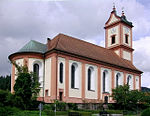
[0,75,11,91]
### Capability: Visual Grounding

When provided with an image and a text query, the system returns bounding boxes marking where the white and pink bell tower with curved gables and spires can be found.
[104,6,134,62]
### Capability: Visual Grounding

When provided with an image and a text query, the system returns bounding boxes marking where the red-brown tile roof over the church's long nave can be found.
[48,34,142,73]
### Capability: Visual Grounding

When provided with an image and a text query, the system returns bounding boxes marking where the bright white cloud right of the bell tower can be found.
[133,36,150,86]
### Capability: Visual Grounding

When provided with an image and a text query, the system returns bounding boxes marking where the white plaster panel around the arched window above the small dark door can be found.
[101,68,112,99]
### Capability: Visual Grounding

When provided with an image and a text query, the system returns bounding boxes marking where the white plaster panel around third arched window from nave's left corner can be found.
[85,64,98,99]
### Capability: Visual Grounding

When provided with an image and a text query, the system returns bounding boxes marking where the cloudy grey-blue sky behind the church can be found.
[0,0,150,87]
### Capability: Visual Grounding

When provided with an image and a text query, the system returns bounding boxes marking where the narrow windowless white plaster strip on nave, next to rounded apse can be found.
[45,58,51,96]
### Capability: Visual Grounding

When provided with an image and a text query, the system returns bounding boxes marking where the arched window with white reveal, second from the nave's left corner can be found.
[71,63,79,88]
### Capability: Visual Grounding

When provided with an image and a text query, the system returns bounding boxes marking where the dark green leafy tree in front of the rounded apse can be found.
[13,63,40,109]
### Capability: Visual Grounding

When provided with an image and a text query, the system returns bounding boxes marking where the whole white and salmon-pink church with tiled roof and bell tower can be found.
[9,7,142,103]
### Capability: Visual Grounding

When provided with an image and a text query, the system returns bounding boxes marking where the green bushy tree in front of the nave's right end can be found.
[111,85,144,109]
